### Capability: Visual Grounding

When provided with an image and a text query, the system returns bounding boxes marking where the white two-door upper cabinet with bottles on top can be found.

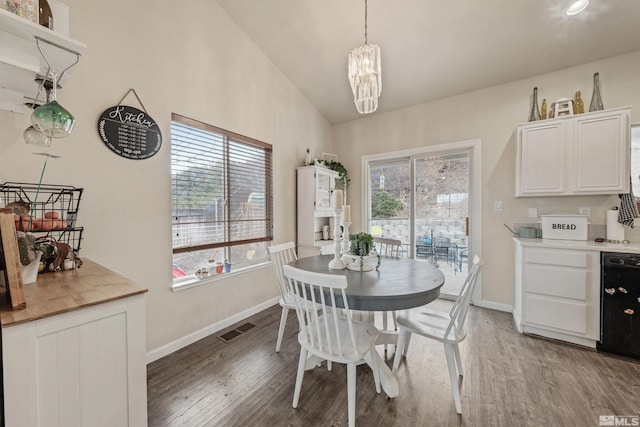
[516,107,631,197]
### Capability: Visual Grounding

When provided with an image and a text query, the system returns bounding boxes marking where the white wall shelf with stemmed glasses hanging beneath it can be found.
[0,9,86,113]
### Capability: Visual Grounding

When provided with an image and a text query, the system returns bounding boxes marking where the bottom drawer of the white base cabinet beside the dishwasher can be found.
[525,295,588,335]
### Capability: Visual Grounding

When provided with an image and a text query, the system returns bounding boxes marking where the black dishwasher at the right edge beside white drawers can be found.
[596,252,640,359]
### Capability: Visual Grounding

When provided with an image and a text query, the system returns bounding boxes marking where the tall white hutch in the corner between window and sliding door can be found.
[296,166,338,258]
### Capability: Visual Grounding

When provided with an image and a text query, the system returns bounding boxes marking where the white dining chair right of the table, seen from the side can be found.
[393,255,482,414]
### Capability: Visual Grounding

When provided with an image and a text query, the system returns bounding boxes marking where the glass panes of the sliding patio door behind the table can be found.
[367,149,471,296]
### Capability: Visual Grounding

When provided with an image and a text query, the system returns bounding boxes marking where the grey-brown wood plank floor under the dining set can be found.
[147,300,640,427]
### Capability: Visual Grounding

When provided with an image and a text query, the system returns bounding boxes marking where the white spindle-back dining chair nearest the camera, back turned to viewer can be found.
[283,265,383,426]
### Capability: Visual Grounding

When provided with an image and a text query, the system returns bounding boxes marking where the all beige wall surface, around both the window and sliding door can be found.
[0,0,640,358]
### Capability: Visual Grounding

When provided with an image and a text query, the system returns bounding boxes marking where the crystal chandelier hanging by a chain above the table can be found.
[349,0,382,114]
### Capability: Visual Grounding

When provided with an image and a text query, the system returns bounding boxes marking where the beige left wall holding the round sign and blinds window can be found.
[0,0,331,358]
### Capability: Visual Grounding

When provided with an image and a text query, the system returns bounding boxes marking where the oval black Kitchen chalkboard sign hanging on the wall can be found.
[98,105,162,160]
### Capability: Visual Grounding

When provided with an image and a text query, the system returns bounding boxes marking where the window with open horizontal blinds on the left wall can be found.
[171,114,273,279]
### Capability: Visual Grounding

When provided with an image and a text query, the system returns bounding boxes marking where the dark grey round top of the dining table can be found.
[289,255,444,311]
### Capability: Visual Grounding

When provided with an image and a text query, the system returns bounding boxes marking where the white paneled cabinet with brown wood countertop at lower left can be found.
[0,259,147,427]
